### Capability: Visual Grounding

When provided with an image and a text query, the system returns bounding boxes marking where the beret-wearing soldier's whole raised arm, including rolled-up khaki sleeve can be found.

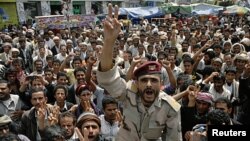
[96,4,126,100]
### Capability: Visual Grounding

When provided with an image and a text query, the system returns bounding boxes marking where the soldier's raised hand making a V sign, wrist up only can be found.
[103,3,121,42]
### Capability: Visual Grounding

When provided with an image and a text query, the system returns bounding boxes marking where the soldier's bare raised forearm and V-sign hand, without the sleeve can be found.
[100,4,121,72]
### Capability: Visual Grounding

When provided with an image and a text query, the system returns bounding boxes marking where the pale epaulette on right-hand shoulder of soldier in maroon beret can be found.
[160,92,181,112]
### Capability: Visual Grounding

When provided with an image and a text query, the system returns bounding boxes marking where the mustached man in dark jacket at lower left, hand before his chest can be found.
[19,88,54,141]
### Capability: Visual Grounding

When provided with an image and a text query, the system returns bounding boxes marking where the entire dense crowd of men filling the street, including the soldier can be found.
[0,5,250,141]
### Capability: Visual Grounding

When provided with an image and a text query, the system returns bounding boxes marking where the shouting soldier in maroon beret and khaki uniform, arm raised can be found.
[97,5,181,141]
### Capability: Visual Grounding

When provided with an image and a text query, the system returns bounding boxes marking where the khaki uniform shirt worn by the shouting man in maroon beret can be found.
[97,66,181,141]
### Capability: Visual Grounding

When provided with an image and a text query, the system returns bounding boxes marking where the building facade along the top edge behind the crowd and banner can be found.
[11,0,165,23]
